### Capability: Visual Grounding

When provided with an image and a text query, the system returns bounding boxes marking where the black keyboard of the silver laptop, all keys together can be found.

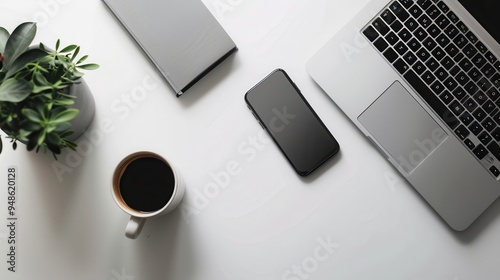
[363,0,500,178]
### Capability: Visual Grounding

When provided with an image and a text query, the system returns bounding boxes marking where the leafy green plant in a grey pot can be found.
[0,22,99,156]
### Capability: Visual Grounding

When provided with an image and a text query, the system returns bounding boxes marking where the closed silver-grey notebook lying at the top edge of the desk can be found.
[103,0,237,96]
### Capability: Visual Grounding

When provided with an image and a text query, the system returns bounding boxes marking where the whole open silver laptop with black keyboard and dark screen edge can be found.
[306,0,500,231]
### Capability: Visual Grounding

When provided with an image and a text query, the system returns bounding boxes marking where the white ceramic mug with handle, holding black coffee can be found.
[112,151,186,239]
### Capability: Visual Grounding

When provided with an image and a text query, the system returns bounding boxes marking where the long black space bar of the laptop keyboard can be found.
[404,70,459,129]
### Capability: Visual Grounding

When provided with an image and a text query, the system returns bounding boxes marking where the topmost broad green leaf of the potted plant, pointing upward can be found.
[3,22,36,69]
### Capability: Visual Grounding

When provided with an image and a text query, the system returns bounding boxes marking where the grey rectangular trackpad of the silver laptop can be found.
[358,81,448,173]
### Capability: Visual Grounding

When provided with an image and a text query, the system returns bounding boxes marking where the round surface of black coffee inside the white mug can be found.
[119,157,175,212]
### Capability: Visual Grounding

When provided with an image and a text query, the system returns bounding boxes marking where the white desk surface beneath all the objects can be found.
[0,0,500,280]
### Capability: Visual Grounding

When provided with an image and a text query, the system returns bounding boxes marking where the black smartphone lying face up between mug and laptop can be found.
[245,69,339,176]
